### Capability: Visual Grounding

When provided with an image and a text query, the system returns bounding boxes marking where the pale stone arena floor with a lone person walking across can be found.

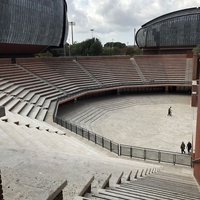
[56,94,197,152]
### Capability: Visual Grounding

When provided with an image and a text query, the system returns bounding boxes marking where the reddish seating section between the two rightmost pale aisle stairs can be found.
[77,57,142,85]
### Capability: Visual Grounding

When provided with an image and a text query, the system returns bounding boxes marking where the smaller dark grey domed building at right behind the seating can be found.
[135,8,200,53]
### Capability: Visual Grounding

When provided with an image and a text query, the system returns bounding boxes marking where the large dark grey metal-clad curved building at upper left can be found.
[0,0,68,55]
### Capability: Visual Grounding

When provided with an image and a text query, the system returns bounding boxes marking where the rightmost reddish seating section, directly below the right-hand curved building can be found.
[134,54,192,83]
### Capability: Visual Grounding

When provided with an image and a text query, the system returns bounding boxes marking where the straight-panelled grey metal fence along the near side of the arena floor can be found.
[54,116,192,166]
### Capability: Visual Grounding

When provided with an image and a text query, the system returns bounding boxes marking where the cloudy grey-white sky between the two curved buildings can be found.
[66,0,200,45]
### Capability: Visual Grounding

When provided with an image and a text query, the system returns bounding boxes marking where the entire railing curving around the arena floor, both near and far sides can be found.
[53,83,192,166]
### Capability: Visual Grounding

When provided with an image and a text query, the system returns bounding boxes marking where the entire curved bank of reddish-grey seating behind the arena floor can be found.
[0,55,191,123]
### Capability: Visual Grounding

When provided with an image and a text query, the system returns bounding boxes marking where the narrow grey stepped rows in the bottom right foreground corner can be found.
[81,170,200,200]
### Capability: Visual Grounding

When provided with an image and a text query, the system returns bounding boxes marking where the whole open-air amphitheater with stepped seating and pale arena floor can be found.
[0,55,200,200]
